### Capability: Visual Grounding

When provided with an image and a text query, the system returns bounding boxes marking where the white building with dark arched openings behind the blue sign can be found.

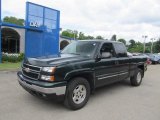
[1,26,73,53]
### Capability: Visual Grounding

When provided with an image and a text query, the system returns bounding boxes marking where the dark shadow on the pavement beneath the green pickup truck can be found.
[25,80,131,112]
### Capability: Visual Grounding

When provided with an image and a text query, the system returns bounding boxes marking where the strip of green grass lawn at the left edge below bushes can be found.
[0,62,21,71]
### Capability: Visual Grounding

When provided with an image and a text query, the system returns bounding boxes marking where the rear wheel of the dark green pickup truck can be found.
[130,69,143,86]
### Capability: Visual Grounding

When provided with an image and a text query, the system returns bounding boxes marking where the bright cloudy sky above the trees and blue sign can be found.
[2,0,160,42]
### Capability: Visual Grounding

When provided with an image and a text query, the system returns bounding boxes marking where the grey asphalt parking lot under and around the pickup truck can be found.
[0,65,160,120]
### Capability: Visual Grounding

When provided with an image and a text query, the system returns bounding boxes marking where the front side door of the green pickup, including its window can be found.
[95,43,118,87]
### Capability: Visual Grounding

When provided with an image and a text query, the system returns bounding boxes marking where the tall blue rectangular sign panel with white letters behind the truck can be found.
[25,2,60,57]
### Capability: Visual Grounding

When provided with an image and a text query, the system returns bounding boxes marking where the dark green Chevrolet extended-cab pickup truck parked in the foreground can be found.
[17,40,147,110]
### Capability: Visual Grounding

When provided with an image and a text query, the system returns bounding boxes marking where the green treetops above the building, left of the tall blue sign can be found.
[2,16,24,26]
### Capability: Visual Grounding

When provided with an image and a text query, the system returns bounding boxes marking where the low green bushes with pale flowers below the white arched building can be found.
[2,53,24,63]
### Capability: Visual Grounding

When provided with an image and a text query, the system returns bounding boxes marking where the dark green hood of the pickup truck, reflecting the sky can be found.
[24,54,91,67]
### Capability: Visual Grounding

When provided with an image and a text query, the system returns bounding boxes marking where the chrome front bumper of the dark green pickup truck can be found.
[18,75,66,96]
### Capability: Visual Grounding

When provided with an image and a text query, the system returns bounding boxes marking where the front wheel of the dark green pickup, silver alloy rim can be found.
[64,77,90,110]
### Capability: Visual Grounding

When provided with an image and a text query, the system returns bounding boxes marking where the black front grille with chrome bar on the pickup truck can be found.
[22,63,41,80]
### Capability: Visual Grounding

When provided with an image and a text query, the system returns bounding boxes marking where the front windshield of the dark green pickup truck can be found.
[61,41,98,56]
